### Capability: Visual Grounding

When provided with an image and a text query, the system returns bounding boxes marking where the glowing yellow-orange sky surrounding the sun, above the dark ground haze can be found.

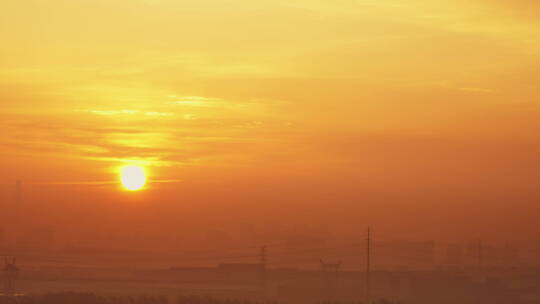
[0,0,540,246]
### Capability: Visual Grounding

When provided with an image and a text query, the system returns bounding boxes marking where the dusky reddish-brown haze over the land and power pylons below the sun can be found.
[0,181,540,304]
